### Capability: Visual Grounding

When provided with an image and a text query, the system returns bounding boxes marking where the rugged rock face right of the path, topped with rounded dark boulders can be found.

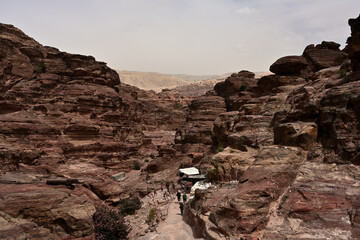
[181,14,360,239]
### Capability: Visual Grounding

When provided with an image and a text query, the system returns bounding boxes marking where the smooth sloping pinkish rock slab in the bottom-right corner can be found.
[263,162,360,240]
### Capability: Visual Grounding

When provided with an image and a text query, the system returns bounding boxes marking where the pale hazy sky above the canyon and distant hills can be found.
[0,0,360,74]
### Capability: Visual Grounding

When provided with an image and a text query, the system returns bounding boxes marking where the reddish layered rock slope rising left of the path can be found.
[0,24,188,239]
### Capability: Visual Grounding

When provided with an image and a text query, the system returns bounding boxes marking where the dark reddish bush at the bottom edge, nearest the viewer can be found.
[93,204,130,240]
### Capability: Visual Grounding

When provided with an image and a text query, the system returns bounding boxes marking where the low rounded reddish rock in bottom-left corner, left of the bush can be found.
[0,183,95,239]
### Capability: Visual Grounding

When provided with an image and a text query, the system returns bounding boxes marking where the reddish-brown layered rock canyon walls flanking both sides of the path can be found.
[0,16,360,240]
